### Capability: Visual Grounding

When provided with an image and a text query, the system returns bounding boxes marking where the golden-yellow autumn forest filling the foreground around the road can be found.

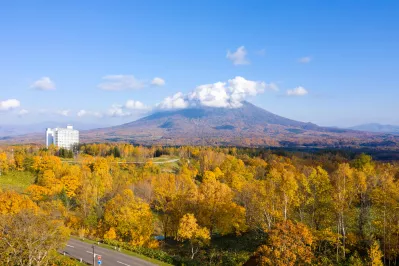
[0,143,399,265]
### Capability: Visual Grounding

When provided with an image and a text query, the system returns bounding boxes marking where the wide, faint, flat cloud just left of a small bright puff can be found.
[98,75,145,91]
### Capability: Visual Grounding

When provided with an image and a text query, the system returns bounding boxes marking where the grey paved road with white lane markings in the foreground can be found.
[64,238,155,266]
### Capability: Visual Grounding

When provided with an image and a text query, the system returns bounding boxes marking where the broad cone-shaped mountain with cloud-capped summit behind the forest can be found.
[82,102,382,146]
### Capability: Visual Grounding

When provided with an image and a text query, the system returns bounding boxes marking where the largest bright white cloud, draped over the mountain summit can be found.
[157,77,270,109]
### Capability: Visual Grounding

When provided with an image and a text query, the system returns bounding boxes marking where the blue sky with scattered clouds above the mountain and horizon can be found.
[0,0,399,126]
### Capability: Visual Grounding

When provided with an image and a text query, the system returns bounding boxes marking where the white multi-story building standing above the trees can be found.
[46,126,79,149]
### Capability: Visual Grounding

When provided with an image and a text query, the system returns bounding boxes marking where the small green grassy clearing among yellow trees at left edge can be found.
[0,171,35,193]
